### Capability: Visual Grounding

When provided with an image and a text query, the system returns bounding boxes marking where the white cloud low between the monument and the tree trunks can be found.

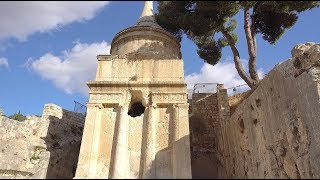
[185,60,263,89]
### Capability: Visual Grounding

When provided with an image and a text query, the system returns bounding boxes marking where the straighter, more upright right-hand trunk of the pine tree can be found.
[244,7,259,84]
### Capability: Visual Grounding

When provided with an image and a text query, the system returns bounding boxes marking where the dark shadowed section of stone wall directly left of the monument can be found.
[44,113,83,179]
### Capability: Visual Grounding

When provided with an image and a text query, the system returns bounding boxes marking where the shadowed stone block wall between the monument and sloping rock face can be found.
[189,86,230,178]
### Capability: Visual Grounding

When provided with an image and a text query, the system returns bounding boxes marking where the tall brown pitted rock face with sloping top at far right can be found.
[220,43,320,178]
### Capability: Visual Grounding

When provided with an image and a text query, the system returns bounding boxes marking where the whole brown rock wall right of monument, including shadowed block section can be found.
[190,43,320,179]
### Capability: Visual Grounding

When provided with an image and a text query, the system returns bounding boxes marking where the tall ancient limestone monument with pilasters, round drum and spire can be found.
[75,1,191,178]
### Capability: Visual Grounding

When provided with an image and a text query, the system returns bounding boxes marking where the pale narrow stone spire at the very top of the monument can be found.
[136,1,160,27]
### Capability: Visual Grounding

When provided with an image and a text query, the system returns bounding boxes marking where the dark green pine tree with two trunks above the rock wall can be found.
[155,1,319,88]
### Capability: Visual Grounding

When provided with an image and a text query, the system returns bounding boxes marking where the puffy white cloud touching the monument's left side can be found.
[27,41,110,94]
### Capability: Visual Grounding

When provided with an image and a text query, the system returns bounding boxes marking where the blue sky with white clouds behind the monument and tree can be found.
[0,1,320,115]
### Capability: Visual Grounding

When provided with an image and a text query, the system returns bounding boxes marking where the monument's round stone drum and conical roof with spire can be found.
[110,1,181,59]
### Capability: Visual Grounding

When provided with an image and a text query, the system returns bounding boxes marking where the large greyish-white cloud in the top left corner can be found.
[0,1,109,40]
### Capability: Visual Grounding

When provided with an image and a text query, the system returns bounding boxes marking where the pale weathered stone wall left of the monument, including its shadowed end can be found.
[0,104,84,179]
